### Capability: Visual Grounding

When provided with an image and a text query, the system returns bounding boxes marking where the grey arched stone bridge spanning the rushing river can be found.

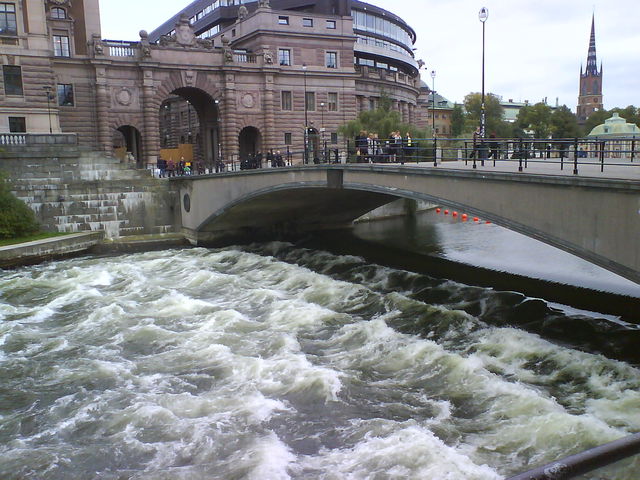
[177,165,640,283]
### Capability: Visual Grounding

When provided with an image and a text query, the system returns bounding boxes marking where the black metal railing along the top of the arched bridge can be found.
[184,137,640,175]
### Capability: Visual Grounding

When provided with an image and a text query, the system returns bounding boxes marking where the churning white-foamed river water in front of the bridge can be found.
[0,234,640,480]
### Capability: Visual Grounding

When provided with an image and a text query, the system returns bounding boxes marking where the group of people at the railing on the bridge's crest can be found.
[355,130,415,164]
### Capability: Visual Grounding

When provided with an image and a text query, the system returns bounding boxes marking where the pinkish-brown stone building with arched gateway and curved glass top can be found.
[0,0,428,166]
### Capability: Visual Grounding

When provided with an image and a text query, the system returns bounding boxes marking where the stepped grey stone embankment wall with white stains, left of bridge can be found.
[7,147,174,238]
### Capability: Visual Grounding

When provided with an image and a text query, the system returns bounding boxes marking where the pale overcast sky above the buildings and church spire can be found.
[100,0,640,110]
